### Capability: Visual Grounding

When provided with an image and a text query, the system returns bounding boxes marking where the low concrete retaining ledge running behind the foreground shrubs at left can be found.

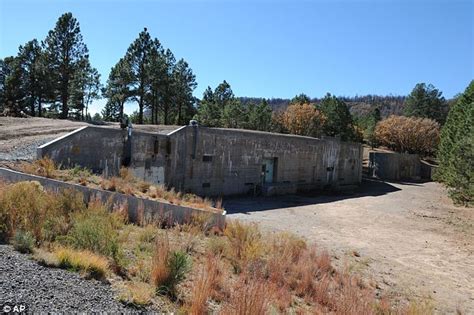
[0,168,225,228]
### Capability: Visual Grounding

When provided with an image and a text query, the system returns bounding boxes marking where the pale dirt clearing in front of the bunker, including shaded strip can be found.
[224,181,474,314]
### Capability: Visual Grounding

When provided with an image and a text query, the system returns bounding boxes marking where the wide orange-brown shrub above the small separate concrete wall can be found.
[375,115,439,155]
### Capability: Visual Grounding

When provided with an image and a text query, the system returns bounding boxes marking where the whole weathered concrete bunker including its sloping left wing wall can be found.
[37,124,362,196]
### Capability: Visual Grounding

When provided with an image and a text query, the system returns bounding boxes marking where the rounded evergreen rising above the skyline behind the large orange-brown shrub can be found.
[403,83,448,124]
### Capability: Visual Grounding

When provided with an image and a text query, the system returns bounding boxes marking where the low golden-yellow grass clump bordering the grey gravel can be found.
[54,248,109,279]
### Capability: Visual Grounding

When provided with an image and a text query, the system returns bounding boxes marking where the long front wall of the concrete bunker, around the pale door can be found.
[167,126,362,196]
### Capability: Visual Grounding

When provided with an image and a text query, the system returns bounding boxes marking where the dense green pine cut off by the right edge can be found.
[435,81,474,206]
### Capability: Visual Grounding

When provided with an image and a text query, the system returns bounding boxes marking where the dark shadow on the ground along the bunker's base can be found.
[223,179,404,214]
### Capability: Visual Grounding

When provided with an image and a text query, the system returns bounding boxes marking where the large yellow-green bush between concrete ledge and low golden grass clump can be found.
[66,201,120,259]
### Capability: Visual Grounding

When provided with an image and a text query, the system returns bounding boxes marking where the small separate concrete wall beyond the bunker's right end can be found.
[369,152,422,180]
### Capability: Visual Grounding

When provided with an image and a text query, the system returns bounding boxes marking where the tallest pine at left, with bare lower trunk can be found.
[45,12,88,118]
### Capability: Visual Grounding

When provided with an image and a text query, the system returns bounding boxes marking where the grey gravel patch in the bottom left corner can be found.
[0,245,133,314]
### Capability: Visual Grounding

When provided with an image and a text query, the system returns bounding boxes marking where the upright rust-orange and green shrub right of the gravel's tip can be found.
[151,236,191,298]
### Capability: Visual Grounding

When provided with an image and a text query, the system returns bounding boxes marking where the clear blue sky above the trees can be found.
[0,0,474,115]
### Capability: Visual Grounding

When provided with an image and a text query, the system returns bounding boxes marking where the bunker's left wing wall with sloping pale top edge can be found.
[37,126,167,184]
